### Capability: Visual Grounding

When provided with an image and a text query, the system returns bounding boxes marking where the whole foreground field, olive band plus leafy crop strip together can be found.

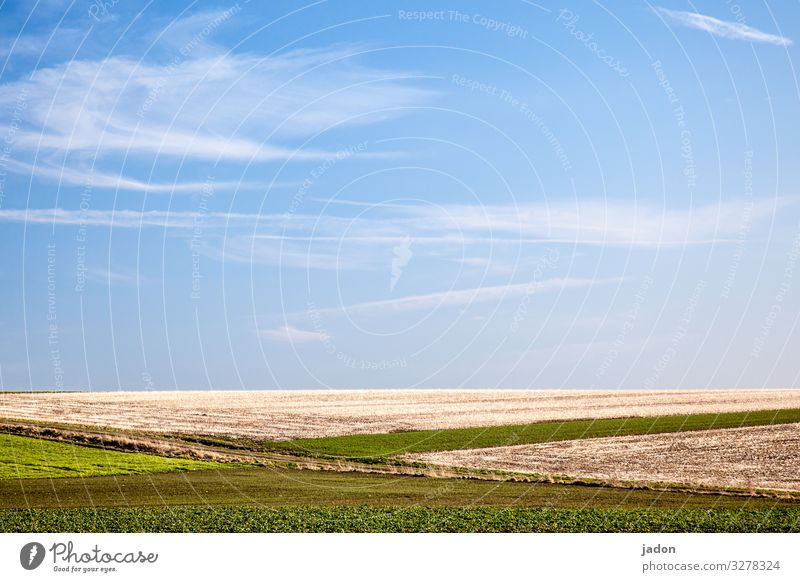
[0,467,800,532]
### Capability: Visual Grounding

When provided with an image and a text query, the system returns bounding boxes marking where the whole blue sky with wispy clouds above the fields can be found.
[0,0,800,390]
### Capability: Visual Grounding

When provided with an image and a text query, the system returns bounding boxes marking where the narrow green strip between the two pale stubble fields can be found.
[268,408,800,460]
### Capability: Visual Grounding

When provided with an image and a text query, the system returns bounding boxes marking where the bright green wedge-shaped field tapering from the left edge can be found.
[0,433,223,480]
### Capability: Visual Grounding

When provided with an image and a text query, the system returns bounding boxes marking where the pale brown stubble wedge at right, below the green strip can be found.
[405,424,800,491]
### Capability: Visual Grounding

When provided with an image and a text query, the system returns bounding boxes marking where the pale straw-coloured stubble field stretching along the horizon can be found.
[0,390,800,440]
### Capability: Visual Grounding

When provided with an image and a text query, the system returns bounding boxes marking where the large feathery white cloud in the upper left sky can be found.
[0,46,431,161]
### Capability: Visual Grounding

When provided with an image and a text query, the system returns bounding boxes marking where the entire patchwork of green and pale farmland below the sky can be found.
[0,390,800,532]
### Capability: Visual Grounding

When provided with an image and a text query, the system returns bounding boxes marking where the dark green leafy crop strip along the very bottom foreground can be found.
[0,506,800,533]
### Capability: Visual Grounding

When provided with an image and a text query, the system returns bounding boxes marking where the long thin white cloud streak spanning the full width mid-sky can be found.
[0,197,800,241]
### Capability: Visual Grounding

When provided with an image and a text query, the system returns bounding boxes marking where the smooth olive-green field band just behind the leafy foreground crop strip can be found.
[0,466,800,509]
